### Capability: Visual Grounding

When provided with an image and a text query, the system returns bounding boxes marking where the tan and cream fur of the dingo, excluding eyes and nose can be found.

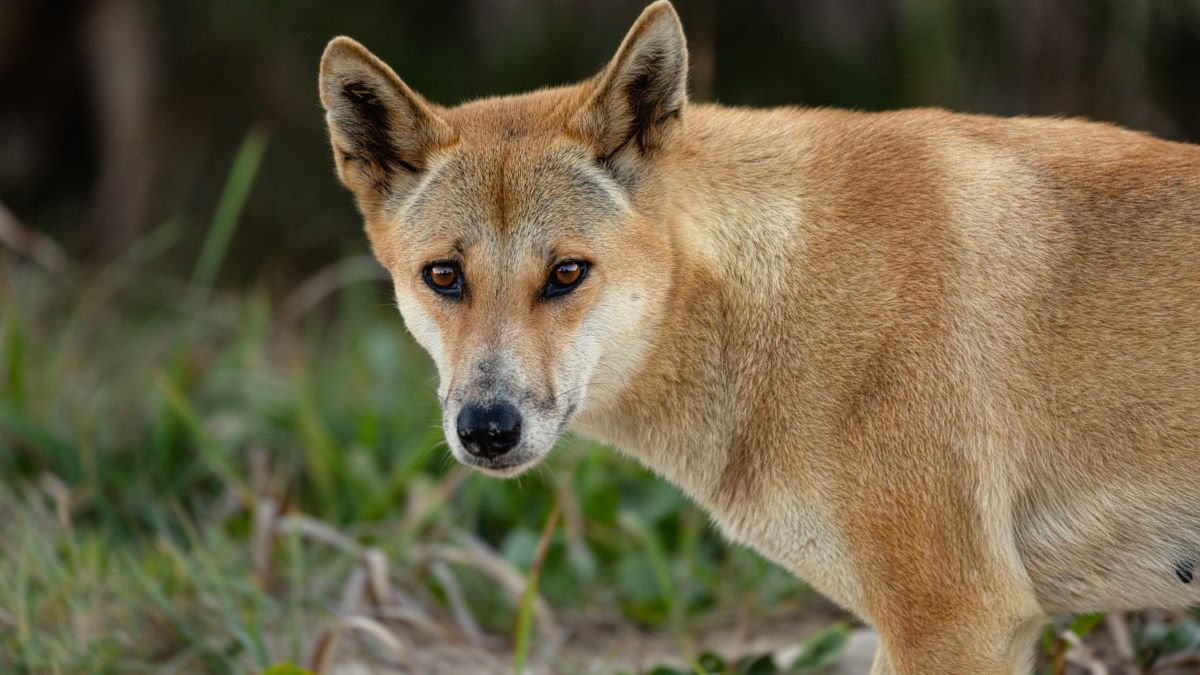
[322,1,1200,674]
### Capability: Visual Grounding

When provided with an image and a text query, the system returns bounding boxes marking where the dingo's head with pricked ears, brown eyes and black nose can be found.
[320,0,688,476]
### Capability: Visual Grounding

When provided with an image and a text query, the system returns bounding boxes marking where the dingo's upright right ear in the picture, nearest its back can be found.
[575,0,688,172]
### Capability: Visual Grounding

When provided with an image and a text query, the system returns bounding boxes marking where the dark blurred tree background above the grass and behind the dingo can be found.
[0,0,1200,276]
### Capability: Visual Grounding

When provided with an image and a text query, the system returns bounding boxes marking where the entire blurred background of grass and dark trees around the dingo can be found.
[0,0,1200,674]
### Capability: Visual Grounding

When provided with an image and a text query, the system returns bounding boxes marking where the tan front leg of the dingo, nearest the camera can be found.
[841,432,1045,675]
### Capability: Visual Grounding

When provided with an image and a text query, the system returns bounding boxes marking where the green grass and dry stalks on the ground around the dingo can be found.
[0,133,1200,675]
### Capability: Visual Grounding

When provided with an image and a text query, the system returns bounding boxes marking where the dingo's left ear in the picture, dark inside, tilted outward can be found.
[320,37,455,216]
